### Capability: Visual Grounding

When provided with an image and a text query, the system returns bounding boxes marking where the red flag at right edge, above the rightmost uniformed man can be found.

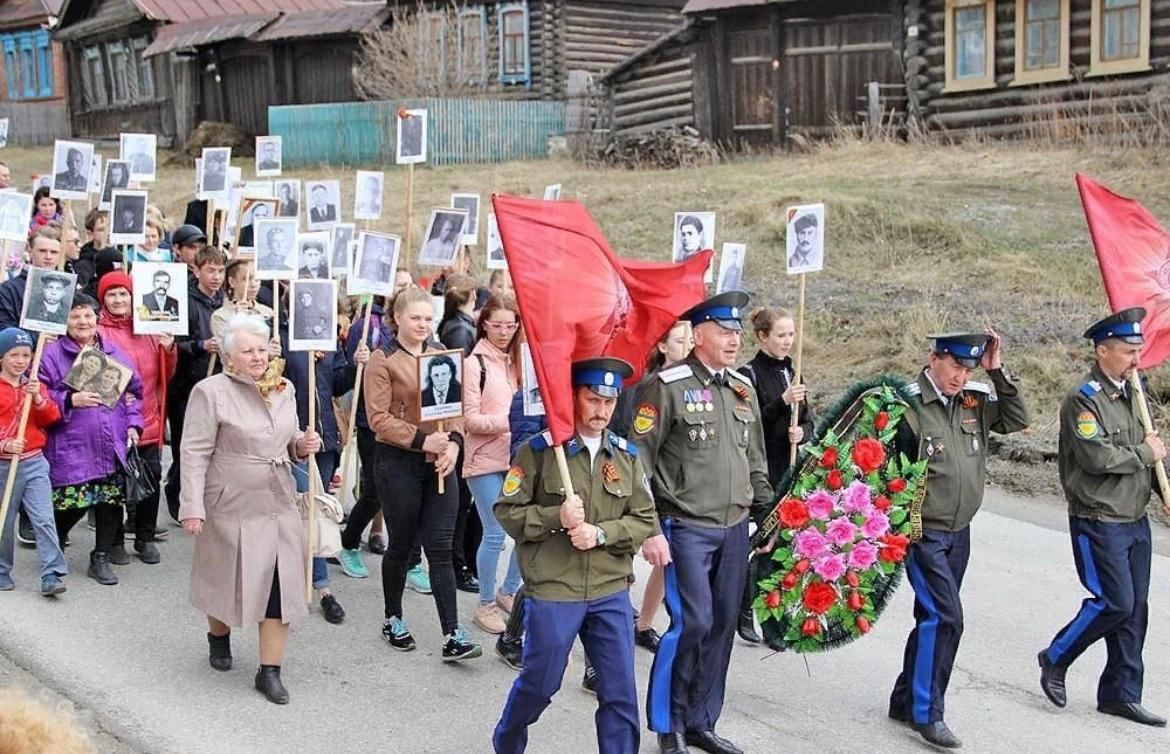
[1076,173,1170,369]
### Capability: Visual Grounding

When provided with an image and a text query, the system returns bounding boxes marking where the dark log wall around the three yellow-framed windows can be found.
[903,0,1170,136]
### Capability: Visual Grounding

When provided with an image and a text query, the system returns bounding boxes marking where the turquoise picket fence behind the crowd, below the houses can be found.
[268,98,565,167]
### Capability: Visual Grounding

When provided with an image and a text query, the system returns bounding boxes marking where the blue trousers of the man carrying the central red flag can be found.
[491,589,640,754]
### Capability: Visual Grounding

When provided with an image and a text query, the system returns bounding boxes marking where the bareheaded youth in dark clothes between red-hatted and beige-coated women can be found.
[166,246,227,526]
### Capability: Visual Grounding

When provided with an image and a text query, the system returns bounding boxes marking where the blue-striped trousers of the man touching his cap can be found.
[889,527,971,725]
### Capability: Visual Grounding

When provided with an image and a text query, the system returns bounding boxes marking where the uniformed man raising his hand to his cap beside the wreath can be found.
[889,330,1028,748]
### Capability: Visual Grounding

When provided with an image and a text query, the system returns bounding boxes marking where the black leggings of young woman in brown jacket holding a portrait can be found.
[374,443,459,635]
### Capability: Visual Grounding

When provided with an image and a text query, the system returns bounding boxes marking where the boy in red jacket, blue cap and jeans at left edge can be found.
[0,328,69,597]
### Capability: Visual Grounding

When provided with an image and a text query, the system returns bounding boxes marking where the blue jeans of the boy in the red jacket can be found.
[0,453,69,578]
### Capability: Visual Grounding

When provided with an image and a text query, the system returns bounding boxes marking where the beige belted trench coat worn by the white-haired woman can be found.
[179,373,309,626]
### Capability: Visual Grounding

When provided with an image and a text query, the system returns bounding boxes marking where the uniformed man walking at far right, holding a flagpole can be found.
[1040,307,1166,726]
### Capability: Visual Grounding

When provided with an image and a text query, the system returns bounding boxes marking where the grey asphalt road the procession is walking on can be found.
[0,491,1170,754]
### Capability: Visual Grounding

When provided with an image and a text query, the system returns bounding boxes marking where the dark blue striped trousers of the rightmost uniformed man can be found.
[1046,516,1152,705]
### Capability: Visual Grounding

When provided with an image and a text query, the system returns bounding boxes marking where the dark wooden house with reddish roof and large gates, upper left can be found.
[54,0,386,145]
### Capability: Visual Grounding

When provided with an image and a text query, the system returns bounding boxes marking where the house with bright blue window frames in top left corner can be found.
[0,0,69,145]
